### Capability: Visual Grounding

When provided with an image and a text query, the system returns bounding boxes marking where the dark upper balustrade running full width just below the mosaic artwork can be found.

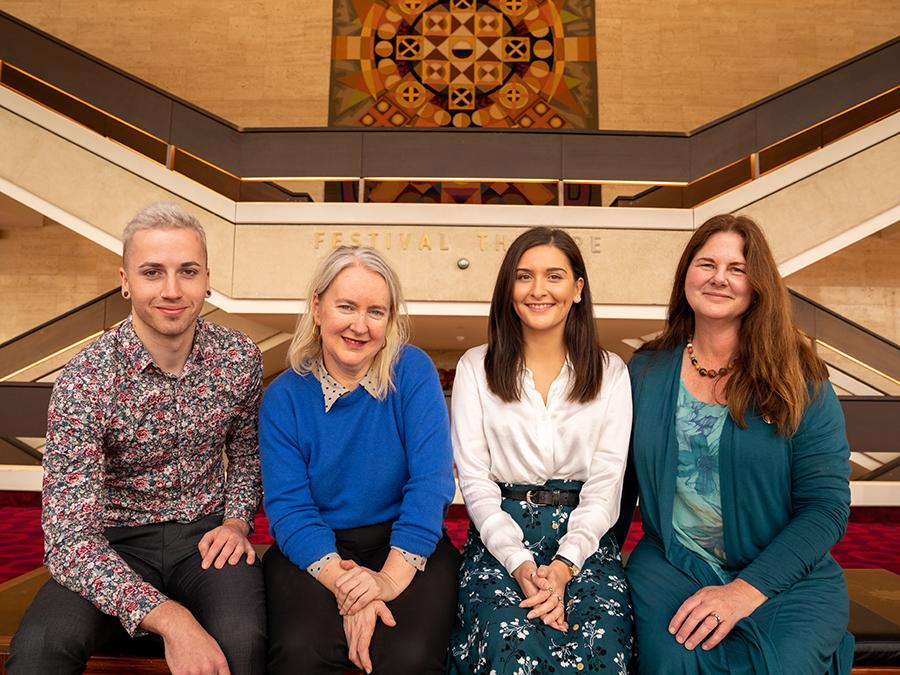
[0,12,900,206]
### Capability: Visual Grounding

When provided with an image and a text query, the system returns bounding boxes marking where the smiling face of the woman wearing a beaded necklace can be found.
[684,232,753,322]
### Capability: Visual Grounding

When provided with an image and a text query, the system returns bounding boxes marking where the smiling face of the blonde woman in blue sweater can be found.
[312,265,391,389]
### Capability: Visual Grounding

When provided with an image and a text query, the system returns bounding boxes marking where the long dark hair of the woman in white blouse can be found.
[484,227,606,403]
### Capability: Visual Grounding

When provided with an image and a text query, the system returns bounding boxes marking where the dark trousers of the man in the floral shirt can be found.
[6,514,266,675]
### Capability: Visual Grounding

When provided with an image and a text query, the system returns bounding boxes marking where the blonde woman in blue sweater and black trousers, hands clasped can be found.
[260,246,459,675]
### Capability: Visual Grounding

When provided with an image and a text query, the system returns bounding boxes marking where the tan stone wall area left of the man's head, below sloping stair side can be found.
[0,218,119,342]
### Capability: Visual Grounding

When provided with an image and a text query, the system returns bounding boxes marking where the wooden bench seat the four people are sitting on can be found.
[0,568,900,675]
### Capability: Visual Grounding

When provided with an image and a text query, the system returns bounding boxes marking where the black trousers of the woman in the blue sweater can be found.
[263,523,460,675]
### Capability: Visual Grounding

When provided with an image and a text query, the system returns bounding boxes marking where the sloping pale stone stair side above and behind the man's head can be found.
[0,109,234,293]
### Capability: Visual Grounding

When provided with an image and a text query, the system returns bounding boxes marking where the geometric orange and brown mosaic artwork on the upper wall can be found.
[329,0,597,129]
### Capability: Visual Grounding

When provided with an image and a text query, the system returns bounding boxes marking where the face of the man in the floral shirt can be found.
[119,228,209,347]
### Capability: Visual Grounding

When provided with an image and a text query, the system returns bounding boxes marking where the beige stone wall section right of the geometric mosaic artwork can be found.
[596,0,900,131]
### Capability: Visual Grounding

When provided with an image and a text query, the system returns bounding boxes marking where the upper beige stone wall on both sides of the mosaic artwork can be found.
[3,0,900,131]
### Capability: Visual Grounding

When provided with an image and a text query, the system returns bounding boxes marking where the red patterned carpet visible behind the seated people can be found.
[0,493,900,582]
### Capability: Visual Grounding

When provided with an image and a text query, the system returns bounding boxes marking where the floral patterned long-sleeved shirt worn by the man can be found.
[41,318,262,635]
